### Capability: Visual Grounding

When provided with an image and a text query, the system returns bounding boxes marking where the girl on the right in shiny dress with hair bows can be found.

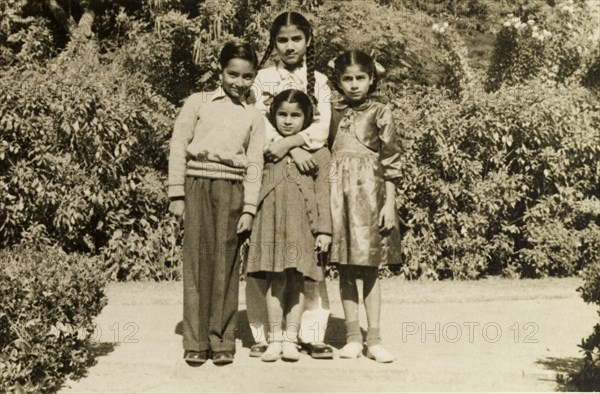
[330,50,401,363]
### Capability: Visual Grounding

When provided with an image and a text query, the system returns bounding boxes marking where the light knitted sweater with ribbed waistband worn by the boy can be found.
[168,88,265,215]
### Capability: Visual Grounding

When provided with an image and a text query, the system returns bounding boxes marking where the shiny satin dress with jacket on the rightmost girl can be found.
[330,100,401,267]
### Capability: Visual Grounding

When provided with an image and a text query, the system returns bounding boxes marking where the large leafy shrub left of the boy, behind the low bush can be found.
[0,46,182,277]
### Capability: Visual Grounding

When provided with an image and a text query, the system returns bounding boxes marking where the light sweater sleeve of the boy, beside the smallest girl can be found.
[243,111,265,215]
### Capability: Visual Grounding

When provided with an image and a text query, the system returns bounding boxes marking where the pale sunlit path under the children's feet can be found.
[62,278,598,393]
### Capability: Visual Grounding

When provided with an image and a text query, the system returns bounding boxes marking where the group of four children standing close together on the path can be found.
[169,12,400,365]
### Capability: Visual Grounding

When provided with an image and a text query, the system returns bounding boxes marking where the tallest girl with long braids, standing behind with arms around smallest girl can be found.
[246,12,333,359]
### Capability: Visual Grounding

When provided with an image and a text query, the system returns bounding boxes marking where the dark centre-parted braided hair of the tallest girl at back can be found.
[258,11,315,96]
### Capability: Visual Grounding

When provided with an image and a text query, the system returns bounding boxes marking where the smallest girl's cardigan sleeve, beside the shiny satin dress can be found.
[313,148,335,235]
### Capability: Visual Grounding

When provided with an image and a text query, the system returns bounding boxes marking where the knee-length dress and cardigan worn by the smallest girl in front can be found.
[246,148,332,281]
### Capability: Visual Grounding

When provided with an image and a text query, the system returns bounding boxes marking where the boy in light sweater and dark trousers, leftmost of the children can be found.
[168,42,265,366]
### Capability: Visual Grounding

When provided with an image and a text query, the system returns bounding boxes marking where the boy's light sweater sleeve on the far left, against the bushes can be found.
[167,95,202,198]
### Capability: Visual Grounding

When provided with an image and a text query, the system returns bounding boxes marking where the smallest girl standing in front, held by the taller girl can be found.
[247,89,331,362]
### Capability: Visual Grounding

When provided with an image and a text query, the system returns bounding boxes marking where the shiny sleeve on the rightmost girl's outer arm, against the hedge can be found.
[377,105,402,181]
